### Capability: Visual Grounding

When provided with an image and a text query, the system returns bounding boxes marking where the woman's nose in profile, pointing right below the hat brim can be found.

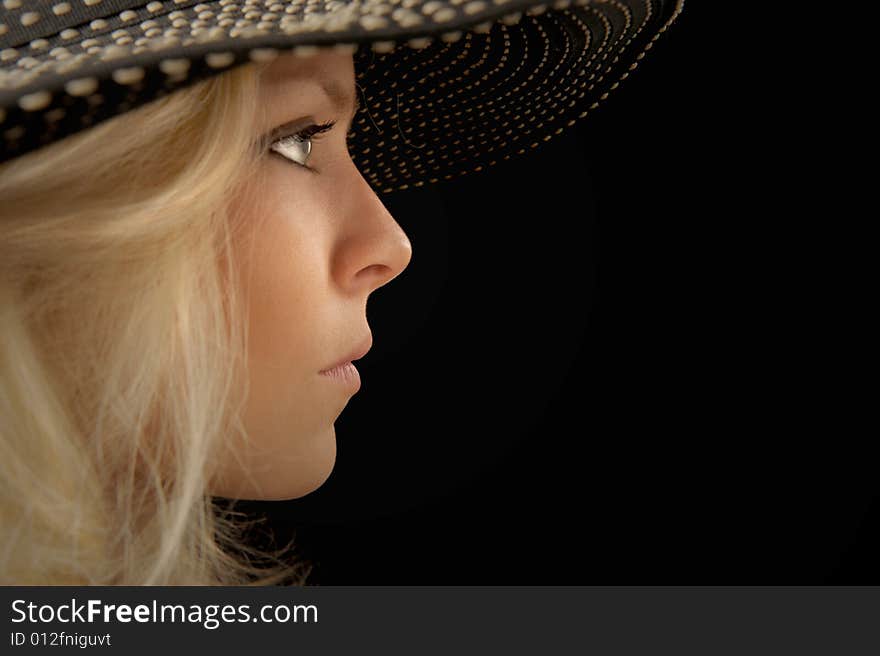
[333,164,412,294]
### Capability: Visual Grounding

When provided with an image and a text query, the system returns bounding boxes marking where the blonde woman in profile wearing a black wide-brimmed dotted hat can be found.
[0,0,681,584]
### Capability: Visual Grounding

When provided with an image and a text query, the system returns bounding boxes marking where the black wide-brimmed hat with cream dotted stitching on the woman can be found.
[0,0,684,192]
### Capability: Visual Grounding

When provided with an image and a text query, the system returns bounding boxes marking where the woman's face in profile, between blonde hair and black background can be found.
[211,50,412,499]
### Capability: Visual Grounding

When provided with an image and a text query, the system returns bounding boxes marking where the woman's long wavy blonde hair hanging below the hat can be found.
[0,64,307,585]
